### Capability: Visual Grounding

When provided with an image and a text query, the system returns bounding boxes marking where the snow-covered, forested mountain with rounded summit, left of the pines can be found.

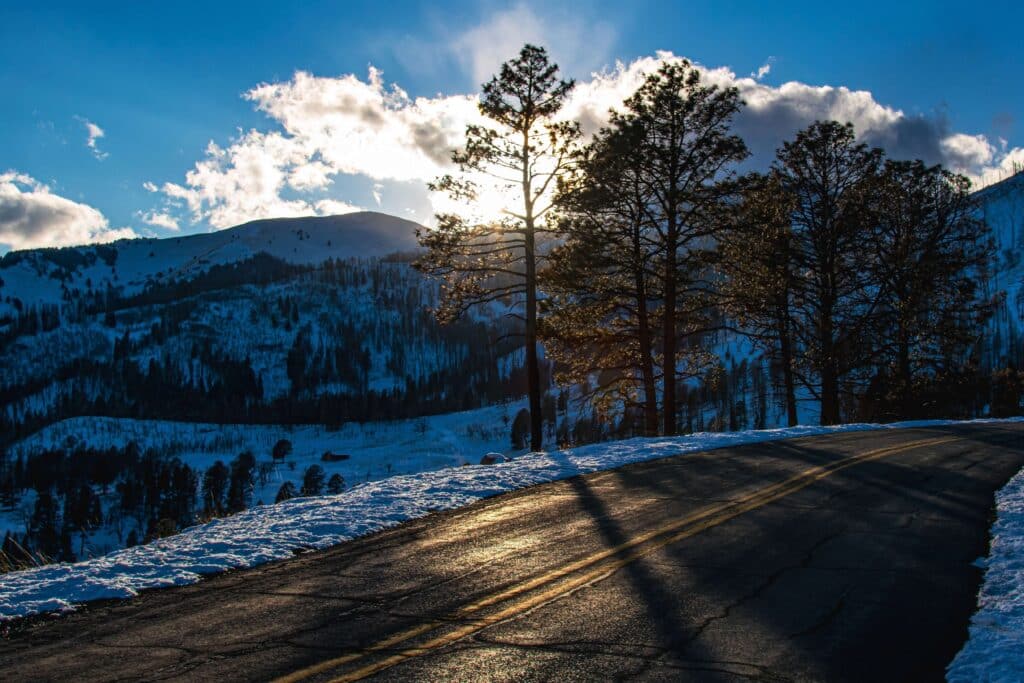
[0,212,522,446]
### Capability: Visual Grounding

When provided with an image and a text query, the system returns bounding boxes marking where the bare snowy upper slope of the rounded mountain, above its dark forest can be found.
[0,211,419,318]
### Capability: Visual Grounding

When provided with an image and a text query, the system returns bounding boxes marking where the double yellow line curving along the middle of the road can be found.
[278,436,959,683]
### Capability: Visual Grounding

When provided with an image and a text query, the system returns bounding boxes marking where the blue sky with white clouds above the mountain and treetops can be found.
[0,1,1024,252]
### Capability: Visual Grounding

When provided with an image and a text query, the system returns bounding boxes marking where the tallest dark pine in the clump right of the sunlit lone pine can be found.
[585,59,749,435]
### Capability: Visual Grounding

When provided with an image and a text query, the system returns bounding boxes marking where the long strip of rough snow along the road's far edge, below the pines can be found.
[0,420,1020,620]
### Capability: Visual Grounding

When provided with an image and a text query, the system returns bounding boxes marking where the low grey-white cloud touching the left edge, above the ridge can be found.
[0,171,137,249]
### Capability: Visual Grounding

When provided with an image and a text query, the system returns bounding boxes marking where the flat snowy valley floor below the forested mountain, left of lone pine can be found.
[0,400,526,558]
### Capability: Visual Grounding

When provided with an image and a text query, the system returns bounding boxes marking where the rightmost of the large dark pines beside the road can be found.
[869,161,995,418]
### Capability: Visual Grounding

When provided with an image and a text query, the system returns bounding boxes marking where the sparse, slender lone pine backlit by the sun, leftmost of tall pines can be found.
[417,45,579,451]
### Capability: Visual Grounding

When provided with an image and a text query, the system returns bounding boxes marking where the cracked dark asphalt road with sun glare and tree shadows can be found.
[0,425,1024,682]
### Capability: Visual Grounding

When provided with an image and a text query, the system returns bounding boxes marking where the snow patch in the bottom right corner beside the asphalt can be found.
[946,470,1024,683]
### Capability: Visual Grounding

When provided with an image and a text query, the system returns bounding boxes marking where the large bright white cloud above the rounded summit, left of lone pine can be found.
[156,68,479,227]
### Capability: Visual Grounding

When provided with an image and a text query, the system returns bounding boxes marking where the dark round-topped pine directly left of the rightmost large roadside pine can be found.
[773,121,882,425]
